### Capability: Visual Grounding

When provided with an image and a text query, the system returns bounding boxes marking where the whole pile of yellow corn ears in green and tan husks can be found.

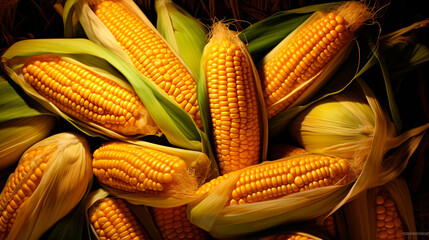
[0,0,429,239]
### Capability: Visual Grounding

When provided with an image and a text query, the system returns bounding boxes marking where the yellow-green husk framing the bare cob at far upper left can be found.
[2,39,202,150]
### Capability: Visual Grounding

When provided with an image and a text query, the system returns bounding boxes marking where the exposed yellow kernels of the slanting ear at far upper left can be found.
[21,55,155,135]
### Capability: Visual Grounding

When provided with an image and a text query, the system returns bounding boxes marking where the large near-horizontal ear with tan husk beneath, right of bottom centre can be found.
[189,154,355,237]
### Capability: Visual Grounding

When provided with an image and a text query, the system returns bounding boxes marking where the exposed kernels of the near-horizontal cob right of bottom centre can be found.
[196,155,349,205]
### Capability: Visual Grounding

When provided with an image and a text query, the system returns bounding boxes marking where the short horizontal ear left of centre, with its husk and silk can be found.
[92,141,212,207]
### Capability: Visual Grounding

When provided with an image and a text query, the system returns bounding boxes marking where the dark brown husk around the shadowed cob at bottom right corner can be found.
[344,177,417,240]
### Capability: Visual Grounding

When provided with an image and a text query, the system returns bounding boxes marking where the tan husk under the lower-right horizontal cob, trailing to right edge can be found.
[188,81,429,237]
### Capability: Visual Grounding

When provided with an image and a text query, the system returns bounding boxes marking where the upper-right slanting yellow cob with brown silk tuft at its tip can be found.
[260,1,372,119]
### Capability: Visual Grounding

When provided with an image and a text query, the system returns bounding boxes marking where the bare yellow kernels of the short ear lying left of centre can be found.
[92,142,198,193]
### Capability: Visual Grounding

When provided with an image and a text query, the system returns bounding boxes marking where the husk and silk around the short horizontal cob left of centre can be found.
[101,141,218,207]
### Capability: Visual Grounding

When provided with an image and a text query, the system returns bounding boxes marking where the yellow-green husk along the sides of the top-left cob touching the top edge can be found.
[63,0,209,151]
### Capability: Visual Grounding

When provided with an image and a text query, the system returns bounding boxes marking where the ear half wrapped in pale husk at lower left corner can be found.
[0,133,92,239]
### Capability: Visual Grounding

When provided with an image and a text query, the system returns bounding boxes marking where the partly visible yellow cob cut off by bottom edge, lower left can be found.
[89,198,150,240]
